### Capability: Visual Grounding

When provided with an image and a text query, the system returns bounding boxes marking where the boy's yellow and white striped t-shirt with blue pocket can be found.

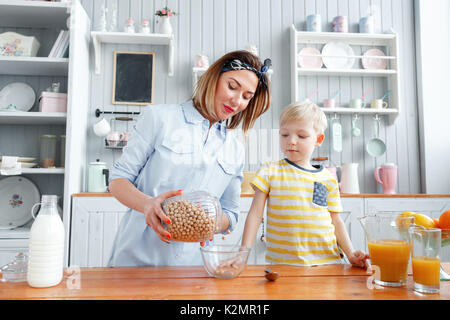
[251,159,342,266]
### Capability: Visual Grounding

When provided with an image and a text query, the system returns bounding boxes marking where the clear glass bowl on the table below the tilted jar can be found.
[200,245,250,279]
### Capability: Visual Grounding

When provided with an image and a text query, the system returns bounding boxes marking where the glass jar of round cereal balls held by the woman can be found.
[162,191,223,242]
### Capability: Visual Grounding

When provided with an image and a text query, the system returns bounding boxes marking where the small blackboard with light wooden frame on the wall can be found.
[112,51,155,105]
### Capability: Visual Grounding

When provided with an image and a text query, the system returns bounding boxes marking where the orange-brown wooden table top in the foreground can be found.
[0,263,450,300]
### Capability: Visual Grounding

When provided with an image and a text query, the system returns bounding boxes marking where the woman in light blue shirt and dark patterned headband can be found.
[109,51,270,266]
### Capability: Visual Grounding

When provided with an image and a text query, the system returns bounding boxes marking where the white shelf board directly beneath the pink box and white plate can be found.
[0,111,67,125]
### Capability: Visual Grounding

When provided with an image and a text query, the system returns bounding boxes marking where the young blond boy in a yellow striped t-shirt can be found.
[242,102,369,268]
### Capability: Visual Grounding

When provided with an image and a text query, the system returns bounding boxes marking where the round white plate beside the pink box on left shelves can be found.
[0,82,36,111]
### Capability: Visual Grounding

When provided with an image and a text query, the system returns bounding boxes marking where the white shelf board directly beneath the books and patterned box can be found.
[0,56,69,77]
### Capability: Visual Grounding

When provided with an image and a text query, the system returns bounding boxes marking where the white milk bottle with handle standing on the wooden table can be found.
[27,195,64,288]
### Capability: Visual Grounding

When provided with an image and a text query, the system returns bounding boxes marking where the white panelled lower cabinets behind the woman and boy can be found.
[70,196,450,267]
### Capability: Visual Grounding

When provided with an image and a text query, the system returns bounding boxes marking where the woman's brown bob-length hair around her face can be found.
[192,50,270,134]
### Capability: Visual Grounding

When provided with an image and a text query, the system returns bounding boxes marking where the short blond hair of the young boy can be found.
[280,101,328,134]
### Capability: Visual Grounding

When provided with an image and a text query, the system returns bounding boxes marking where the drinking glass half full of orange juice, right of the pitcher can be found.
[409,227,441,293]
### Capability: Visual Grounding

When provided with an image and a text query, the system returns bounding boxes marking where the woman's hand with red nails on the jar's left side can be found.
[143,190,183,243]
